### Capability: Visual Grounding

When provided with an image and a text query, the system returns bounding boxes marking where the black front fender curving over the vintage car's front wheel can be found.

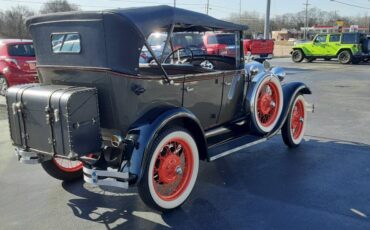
[266,82,312,137]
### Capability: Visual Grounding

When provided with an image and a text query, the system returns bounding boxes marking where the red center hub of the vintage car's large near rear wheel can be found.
[158,154,183,183]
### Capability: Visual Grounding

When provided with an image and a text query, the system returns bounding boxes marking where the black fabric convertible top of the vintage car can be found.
[26,6,248,74]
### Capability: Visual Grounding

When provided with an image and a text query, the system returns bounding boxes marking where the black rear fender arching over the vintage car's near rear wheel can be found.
[126,107,207,184]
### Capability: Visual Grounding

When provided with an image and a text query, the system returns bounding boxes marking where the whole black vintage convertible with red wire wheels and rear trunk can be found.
[6,6,311,210]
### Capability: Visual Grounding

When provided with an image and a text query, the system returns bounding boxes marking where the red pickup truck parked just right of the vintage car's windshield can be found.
[243,39,275,62]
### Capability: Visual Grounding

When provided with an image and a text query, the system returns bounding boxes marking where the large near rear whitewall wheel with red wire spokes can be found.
[138,127,199,211]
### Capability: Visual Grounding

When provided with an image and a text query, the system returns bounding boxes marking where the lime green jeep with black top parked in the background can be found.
[291,33,370,64]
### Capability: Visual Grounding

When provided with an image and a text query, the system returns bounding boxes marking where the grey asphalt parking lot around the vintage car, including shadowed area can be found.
[0,59,370,230]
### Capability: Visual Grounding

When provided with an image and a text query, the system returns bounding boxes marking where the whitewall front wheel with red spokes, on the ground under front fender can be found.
[281,95,307,148]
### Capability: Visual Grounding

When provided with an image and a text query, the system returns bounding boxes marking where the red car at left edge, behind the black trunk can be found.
[0,39,38,95]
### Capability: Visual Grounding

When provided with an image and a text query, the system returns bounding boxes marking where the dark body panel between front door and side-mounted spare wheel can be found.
[218,70,245,124]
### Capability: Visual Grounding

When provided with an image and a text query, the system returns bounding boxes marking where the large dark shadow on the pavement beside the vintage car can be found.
[63,137,370,229]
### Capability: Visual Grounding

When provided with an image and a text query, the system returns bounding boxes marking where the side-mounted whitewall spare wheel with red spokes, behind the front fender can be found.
[255,78,283,133]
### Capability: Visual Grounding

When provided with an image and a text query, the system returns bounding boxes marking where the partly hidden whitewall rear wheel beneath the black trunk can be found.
[41,158,83,181]
